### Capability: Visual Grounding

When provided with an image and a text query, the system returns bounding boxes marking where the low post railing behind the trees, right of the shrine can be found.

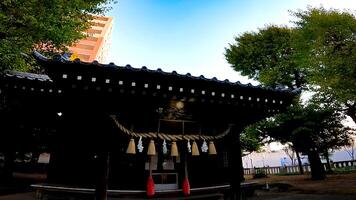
[244,160,356,175]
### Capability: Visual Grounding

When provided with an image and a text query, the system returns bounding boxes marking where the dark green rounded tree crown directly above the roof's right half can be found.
[225,25,305,89]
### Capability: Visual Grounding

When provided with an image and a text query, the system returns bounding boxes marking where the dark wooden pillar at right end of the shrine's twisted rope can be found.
[228,125,244,200]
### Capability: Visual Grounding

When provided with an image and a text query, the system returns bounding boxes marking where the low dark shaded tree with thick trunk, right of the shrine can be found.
[247,104,350,180]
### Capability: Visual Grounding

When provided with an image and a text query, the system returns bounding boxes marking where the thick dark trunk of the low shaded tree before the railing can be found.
[308,149,325,180]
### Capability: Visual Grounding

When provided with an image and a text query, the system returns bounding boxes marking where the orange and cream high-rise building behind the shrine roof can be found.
[68,16,113,63]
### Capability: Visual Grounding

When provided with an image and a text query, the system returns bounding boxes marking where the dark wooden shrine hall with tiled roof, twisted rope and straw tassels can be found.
[0,52,298,200]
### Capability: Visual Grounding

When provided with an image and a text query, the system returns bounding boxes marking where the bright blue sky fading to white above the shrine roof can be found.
[107,0,356,84]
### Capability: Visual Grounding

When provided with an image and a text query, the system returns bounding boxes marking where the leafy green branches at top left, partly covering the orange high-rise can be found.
[0,0,113,71]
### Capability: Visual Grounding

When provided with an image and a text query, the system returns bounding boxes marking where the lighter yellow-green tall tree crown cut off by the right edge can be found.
[294,8,356,122]
